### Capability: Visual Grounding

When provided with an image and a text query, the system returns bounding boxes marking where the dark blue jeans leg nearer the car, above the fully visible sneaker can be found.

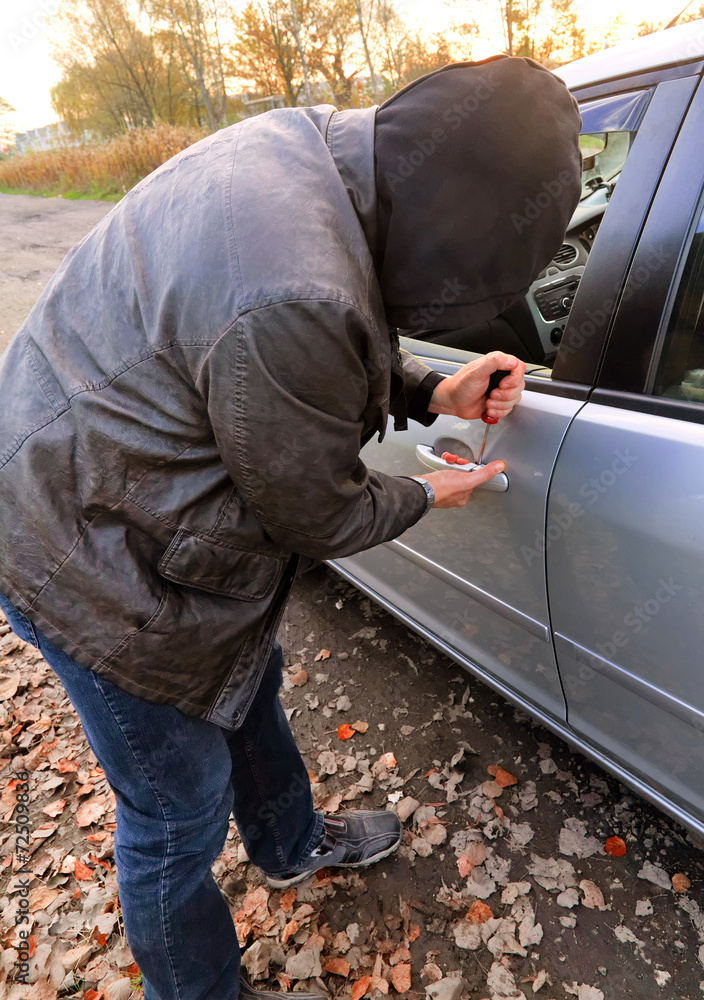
[225,643,323,875]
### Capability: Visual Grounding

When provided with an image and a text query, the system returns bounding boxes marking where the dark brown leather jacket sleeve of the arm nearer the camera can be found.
[198,299,426,559]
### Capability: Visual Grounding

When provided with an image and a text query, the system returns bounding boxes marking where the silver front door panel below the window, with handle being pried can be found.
[332,364,584,720]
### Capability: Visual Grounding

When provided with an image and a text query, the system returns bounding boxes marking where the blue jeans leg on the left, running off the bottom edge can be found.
[2,602,240,1000]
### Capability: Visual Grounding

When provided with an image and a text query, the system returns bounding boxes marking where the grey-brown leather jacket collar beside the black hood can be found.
[326,106,378,258]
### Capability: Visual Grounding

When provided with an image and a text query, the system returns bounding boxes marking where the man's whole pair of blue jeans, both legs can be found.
[0,595,323,1000]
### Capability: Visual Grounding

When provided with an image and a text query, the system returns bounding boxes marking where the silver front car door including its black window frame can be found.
[335,72,693,721]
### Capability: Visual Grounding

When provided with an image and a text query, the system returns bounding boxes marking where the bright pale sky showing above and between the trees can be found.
[0,0,684,132]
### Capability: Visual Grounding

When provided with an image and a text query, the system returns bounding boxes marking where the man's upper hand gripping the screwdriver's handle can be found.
[428,351,526,420]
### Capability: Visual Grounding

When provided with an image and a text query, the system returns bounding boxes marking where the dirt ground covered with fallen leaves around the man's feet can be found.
[0,197,704,1000]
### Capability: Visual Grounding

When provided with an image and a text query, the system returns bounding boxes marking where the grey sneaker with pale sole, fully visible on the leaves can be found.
[266,809,402,889]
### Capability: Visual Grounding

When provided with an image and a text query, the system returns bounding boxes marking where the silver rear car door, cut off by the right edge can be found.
[547,76,704,829]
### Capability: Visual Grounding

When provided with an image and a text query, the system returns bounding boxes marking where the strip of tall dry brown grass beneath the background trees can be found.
[0,125,206,198]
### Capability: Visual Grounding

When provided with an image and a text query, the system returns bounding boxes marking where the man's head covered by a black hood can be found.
[374,56,581,329]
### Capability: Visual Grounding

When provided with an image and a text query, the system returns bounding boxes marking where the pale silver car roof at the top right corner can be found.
[555,19,704,90]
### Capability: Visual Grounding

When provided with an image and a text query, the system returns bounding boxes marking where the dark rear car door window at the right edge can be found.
[653,202,704,403]
